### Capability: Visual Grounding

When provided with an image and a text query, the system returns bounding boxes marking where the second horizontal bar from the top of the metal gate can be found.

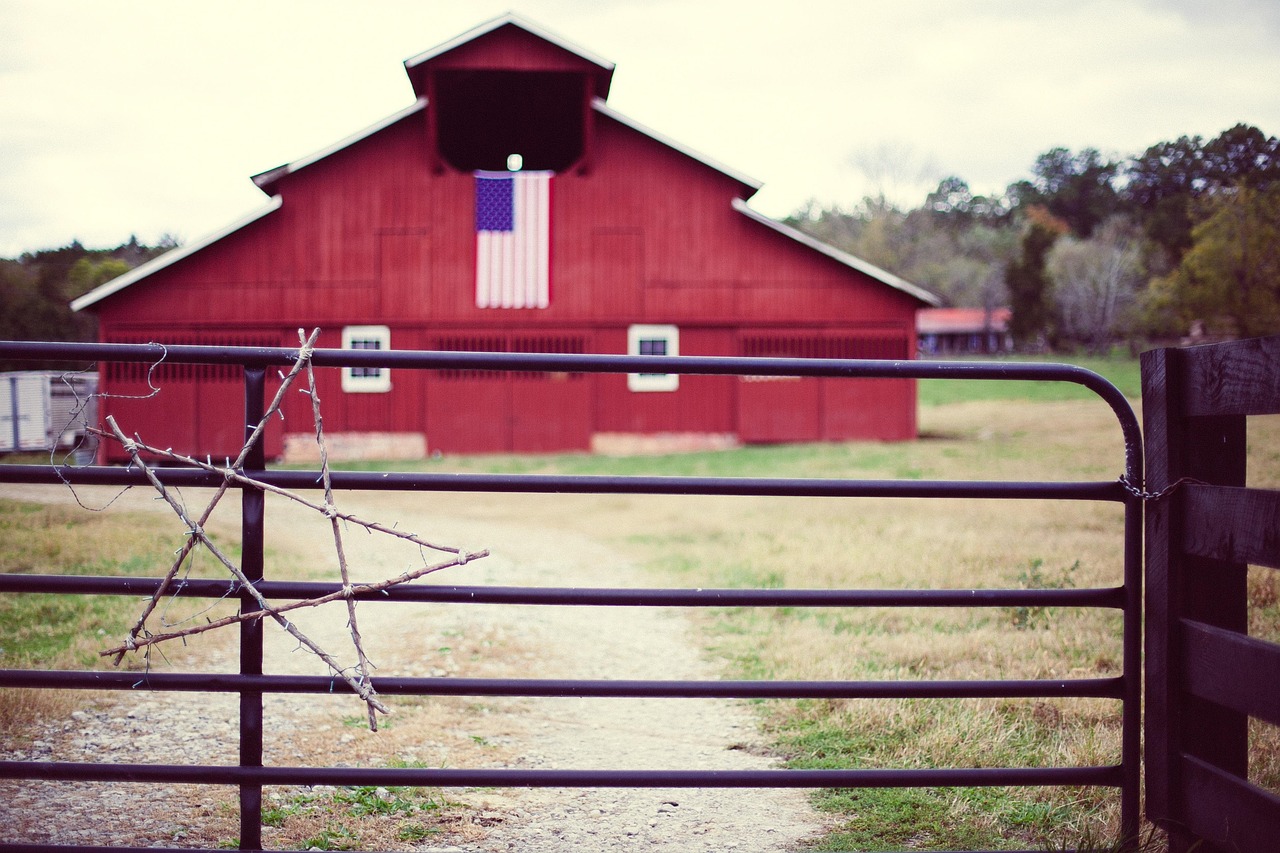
[4,460,1132,502]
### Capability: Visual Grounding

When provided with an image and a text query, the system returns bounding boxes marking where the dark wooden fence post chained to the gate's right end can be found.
[1142,348,1248,853]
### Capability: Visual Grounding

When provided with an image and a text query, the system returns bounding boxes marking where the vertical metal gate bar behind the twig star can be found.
[239,366,266,850]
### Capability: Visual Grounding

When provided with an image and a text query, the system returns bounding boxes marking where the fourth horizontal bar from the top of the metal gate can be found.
[0,670,1124,699]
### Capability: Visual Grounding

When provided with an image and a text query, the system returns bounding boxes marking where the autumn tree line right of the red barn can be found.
[787,124,1280,351]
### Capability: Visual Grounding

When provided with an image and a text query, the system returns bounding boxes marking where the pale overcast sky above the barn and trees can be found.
[0,0,1280,257]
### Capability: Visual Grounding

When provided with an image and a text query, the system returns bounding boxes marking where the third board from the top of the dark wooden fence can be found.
[1180,620,1280,725]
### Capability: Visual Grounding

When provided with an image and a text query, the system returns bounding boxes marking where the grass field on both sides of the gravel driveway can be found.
[0,348,1280,850]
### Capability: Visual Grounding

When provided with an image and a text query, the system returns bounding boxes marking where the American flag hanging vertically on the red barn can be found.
[475,172,553,309]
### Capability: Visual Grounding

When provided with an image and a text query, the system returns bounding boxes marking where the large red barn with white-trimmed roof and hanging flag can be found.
[73,15,937,456]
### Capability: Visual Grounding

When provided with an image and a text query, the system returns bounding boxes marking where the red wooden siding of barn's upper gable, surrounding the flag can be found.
[104,106,916,328]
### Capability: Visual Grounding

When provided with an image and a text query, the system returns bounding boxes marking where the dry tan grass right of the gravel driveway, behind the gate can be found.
[521,402,1152,847]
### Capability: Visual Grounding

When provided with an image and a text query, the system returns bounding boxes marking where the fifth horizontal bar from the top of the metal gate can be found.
[0,761,1121,788]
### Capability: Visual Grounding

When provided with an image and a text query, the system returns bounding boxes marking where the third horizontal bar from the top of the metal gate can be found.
[0,574,1124,608]
